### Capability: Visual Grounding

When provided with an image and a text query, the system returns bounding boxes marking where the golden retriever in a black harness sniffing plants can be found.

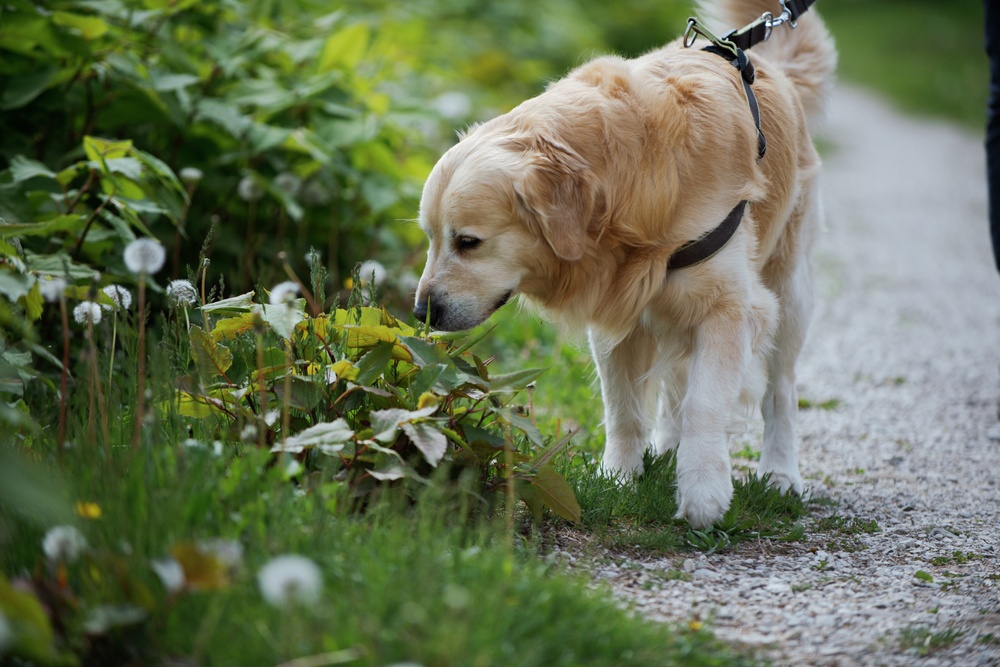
[414,0,836,527]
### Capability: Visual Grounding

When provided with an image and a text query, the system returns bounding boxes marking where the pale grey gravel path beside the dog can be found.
[572,88,1000,665]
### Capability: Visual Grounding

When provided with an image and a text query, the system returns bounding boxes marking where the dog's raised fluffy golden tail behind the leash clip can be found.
[698,0,837,122]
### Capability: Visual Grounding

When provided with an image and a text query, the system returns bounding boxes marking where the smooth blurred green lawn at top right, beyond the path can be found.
[817,0,989,130]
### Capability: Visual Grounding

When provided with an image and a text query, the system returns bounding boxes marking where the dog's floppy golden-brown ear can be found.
[514,136,595,261]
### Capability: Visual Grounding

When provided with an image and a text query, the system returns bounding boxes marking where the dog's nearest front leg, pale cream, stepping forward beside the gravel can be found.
[677,309,753,528]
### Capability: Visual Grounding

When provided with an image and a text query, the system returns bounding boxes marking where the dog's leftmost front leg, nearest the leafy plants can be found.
[588,326,656,480]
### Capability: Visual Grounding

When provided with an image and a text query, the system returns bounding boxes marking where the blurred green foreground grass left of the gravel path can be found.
[0,446,752,667]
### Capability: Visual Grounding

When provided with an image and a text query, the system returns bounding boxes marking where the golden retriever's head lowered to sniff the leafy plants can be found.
[414,124,595,331]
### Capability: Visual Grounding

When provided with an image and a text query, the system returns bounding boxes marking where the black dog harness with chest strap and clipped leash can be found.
[667,0,816,270]
